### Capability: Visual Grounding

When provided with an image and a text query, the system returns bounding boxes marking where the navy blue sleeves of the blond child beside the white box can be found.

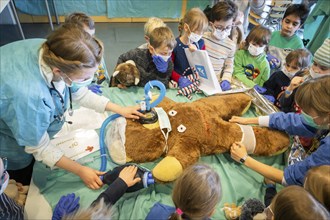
[172,37,205,75]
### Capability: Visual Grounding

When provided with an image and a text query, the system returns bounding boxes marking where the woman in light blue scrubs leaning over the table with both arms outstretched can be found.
[0,25,142,189]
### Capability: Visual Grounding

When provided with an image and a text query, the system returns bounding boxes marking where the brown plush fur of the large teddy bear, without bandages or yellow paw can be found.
[125,94,289,177]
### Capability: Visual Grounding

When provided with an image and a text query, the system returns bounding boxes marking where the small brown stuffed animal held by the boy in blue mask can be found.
[110,60,140,89]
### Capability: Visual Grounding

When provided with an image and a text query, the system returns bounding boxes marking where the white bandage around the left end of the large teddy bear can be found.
[104,117,127,164]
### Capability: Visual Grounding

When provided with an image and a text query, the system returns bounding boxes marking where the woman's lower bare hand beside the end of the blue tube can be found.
[77,166,105,189]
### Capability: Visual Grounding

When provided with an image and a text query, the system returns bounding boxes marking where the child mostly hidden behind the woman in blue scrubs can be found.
[65,12,110,90]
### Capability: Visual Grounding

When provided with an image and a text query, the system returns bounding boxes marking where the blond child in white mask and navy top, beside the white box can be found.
[171,8,208,88]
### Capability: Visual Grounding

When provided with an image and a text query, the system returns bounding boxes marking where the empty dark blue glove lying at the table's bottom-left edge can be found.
[52,193,80,220]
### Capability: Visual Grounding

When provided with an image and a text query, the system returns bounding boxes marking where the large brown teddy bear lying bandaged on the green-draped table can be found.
[106,93,289,182]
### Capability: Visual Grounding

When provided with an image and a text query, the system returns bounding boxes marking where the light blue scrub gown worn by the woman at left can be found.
[0,39,68,170]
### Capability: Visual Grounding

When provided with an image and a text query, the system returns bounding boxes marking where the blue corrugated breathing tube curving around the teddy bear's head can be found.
[99,80,166,173]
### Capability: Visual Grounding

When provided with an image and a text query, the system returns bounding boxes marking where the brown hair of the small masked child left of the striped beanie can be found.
[285,48,312,69]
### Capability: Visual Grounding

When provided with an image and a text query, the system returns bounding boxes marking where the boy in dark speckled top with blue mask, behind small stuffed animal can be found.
[117,27,175,87]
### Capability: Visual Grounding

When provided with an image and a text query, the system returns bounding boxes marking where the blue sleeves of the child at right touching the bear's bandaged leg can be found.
[269,112,330,186]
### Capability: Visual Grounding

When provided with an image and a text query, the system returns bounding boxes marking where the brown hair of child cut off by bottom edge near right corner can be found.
[272,186,330,220]
